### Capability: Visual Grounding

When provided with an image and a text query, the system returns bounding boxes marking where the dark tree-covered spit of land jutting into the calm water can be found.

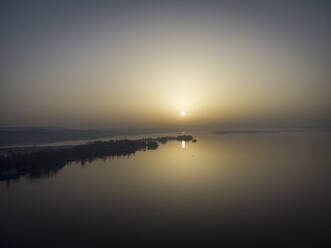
[0,135,196,181]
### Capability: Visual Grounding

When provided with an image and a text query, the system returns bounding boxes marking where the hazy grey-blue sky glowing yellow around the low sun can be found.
[0,0,331,128]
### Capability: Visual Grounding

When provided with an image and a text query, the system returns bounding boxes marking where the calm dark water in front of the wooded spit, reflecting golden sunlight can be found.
[0,133,331,247]
